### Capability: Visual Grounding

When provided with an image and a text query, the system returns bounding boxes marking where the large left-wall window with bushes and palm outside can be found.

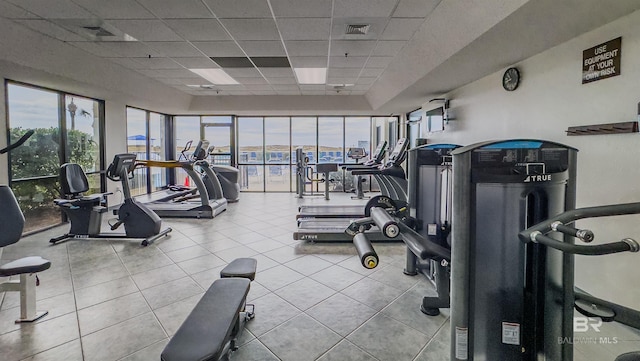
[6,82,105,232]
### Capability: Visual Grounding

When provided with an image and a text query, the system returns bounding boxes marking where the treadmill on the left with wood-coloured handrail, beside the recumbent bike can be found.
[135,140,227,218]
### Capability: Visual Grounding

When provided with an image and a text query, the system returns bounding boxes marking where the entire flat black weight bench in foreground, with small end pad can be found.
[160,258,257,361]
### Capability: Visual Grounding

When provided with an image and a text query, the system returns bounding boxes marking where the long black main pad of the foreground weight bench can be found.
[160,278,250,361]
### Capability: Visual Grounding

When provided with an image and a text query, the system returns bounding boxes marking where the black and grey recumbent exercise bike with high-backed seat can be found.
[49,154,171,246]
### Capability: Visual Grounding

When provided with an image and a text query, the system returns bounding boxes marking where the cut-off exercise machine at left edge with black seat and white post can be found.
[0,130,51,323]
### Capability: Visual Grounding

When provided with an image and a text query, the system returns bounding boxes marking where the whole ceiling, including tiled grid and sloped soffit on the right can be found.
[0,0,640,114]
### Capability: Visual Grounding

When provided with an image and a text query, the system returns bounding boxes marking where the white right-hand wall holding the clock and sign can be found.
[423,12,640,309]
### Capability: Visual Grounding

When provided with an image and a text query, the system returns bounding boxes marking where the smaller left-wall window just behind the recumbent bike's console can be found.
[127,107,168,195]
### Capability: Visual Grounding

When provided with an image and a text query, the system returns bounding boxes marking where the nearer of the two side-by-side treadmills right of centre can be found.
[293,138,408,242]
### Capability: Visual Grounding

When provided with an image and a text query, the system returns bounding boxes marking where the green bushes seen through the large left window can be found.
[11,127,98,213]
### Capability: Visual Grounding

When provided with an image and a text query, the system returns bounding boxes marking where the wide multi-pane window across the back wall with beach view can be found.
[237,116,382,192]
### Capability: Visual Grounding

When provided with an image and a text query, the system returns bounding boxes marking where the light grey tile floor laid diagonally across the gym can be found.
[0,193,636,361]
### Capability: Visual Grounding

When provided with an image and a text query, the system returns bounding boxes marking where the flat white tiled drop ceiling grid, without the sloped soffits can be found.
[0,0,439,95]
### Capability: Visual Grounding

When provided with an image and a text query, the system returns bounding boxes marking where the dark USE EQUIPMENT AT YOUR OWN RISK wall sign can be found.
[582,37,622,84]
